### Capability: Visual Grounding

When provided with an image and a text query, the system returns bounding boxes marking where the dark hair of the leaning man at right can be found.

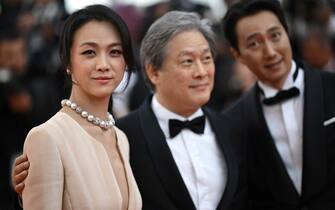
[222,0,288,50]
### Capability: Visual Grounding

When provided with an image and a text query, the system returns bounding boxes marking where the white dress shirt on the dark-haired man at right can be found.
[258,61,304,194]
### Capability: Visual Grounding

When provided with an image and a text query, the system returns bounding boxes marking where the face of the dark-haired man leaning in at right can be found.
[232,11,292,89]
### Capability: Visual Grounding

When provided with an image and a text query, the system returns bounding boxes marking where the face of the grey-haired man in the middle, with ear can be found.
[147,30,215,116]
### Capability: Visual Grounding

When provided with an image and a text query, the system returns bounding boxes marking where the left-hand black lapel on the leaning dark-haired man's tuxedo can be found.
[244,86,299,202]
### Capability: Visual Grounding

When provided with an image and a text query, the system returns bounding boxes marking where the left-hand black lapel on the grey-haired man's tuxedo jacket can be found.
[139,100,195,210]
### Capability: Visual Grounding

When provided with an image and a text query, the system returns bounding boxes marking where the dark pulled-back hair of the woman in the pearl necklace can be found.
[59,5,136,88]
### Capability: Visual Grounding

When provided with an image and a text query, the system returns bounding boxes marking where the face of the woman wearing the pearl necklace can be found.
[69,21,126,98]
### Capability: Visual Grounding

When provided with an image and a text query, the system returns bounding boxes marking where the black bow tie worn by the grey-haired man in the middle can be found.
[169,116,205,138]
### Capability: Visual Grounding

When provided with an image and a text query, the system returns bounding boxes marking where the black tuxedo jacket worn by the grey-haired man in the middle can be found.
[117,98,246,210]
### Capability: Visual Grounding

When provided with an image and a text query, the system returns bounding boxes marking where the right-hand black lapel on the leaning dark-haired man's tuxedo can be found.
[302,68,327,200]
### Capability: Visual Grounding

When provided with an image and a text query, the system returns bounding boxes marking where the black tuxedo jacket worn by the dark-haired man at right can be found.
[224,66,335,210]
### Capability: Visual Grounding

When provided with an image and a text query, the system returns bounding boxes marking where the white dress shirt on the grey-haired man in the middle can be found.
[151,96,227,210]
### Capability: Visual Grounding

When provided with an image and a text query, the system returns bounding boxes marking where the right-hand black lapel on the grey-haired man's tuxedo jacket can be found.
[203,108,238,209]
